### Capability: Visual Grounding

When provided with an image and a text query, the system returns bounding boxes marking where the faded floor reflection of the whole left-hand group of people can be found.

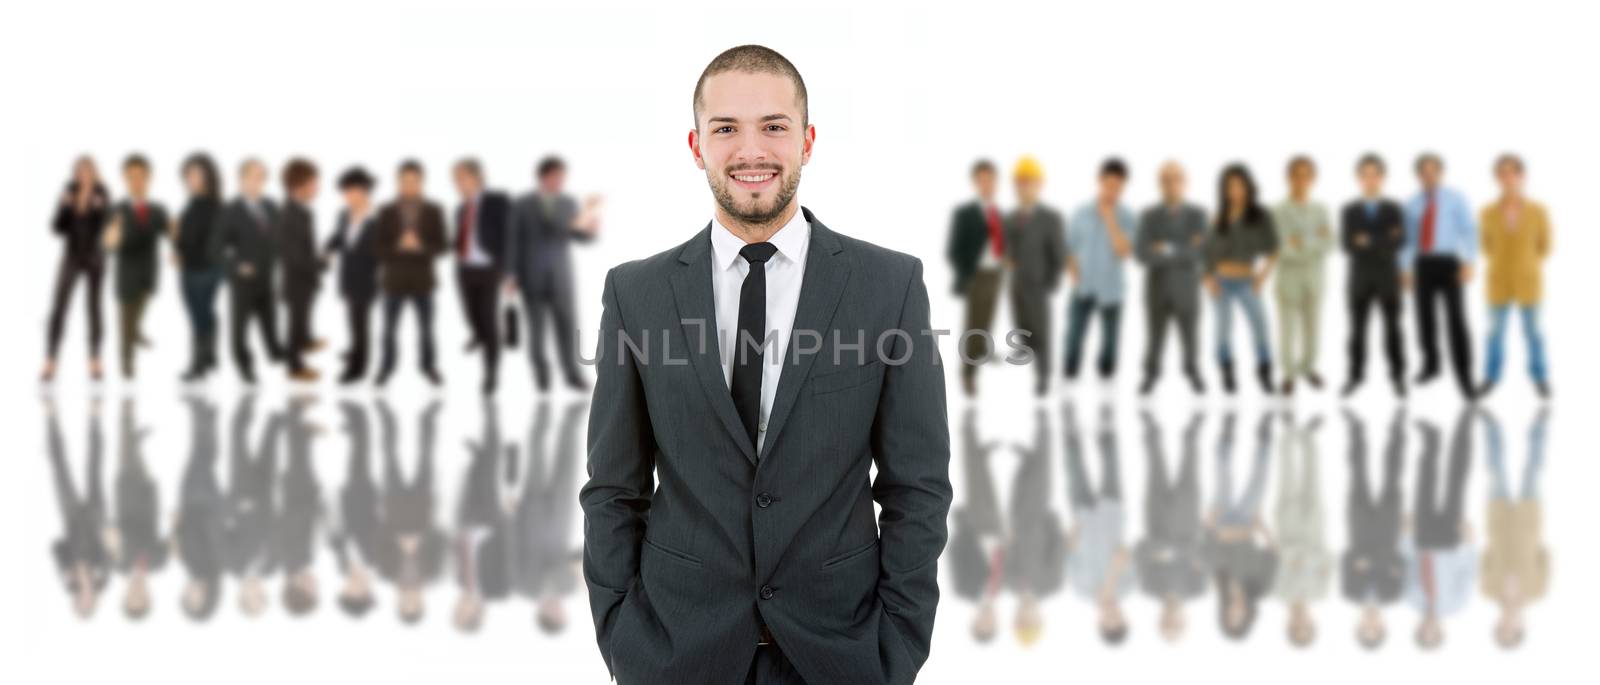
[45,394,587,632]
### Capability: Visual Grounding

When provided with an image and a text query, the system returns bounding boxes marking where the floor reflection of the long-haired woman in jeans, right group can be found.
[1203,413,1278,640]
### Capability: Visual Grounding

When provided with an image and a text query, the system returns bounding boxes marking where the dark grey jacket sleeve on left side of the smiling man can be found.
[578,269,656,669]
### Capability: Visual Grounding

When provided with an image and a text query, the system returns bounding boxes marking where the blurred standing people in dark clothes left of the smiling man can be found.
[40,154,600,394]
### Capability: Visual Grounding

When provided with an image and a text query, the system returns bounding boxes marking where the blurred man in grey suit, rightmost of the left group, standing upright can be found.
[509,157,600,391]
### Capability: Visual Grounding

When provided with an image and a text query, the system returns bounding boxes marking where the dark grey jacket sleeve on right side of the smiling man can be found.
[870,261,947,682]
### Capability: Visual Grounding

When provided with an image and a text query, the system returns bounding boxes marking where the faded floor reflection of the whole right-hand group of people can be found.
[946,403,1550,650]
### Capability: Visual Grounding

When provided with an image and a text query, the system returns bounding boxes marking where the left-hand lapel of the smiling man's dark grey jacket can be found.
[672,221,755,464]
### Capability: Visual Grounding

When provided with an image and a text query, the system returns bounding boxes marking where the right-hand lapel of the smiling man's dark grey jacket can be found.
[758,206,850,459]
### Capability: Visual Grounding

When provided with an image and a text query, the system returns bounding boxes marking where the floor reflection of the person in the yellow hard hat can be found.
[1005,410,1067,647]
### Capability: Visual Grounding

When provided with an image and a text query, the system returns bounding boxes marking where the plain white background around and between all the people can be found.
[0,2,1600,683]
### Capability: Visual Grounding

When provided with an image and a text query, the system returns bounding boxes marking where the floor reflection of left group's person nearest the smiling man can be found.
[512,400,589,634]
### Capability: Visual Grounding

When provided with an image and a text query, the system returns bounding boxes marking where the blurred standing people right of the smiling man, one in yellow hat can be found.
[947,154,1552,400]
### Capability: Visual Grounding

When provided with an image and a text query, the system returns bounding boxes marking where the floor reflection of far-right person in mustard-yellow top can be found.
[1482,407,1550,650]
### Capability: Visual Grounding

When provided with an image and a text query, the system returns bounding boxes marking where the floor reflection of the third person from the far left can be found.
[173,397,232,621]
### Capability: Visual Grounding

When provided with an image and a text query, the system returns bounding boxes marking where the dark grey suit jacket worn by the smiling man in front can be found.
[579,208,950,683]
